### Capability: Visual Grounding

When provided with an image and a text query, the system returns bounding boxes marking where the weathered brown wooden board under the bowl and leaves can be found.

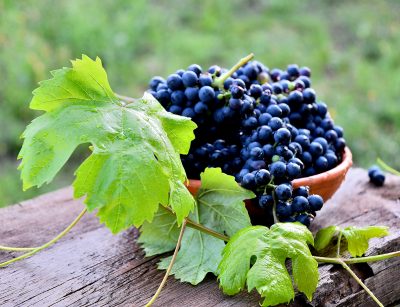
[0,169,400,306]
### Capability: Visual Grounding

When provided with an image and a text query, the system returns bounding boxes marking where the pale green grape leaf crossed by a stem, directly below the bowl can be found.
[155,168,254,285]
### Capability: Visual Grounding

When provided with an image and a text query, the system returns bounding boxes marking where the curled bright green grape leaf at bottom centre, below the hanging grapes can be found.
[218,223,319,306]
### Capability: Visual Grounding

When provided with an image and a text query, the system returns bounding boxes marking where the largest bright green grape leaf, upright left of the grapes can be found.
[19,55,196,233]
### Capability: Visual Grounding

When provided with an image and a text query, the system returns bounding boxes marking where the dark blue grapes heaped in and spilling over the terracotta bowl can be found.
[149,56,346,226]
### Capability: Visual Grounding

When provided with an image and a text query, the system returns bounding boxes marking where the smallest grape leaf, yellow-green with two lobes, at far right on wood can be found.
[315,226,389,257]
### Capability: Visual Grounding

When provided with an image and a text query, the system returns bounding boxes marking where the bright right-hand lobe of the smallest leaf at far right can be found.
[342,226,389,257]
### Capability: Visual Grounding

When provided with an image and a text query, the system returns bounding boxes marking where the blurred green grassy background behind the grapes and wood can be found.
[0,0,400,207]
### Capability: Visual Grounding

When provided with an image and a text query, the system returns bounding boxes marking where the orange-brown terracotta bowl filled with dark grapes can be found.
[188,147,353,202]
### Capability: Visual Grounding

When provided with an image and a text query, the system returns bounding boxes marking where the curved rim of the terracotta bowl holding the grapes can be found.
[187,146,353,191]
